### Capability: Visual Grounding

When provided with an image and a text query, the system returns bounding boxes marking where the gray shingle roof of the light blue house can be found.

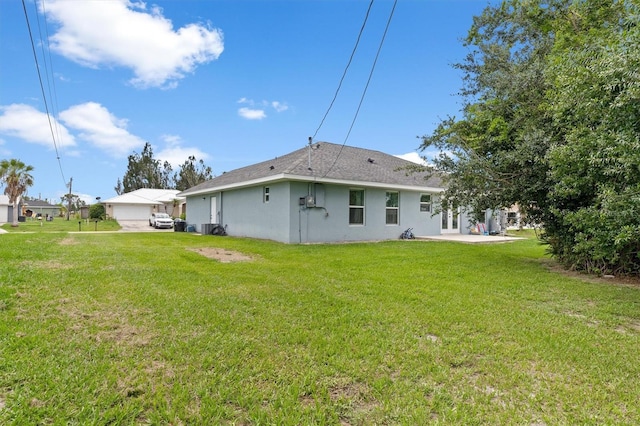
[179,142,442,196]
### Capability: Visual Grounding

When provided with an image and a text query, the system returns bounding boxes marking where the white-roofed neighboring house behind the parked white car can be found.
[102,188,184,220]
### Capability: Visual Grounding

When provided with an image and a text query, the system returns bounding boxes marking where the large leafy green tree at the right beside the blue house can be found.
[422,0,640,275]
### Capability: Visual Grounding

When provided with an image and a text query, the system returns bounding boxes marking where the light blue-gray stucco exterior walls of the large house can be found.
[186,182,470,243]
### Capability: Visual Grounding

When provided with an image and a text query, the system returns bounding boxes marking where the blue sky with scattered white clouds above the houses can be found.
[0,0,487,203]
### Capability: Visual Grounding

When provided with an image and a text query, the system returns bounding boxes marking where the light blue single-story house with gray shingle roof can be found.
[179,142,470,243]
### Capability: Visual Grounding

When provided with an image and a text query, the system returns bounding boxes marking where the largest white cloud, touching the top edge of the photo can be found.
[43,0,224,88]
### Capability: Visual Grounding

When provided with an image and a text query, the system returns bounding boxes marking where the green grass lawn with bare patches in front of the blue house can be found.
[0,232,640,425]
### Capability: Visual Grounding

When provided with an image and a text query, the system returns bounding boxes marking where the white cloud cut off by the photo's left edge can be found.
[0,104,76,149]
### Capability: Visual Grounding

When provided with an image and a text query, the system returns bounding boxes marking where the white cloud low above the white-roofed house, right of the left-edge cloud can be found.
[60,102,145,157]
